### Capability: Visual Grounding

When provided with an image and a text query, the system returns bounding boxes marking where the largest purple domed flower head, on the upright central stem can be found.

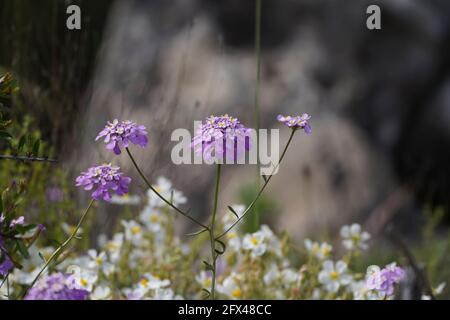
[191,114,251,162]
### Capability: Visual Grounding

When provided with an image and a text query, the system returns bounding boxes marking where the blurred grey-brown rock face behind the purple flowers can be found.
[77,0,450,236]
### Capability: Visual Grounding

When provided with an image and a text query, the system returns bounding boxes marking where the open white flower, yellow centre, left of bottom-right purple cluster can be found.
[319,260,352,292]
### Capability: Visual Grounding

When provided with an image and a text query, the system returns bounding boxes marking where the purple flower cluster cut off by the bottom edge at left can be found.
[25,273,89,300]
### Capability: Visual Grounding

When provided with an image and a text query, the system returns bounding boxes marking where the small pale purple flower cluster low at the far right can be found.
[366,263,405,296]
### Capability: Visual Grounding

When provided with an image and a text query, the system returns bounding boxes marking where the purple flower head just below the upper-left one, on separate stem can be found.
[76,164,131,201]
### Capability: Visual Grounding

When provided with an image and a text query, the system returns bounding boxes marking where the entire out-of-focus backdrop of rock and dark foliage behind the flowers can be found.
[0,0,450,294]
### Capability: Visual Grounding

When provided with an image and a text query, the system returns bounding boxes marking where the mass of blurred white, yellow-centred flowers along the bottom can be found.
[2,178,440,300]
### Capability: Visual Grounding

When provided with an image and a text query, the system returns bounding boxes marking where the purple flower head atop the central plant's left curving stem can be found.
[95,119,148,154]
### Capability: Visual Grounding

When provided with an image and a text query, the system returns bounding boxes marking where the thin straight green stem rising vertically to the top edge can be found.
[252,0,261,229]
